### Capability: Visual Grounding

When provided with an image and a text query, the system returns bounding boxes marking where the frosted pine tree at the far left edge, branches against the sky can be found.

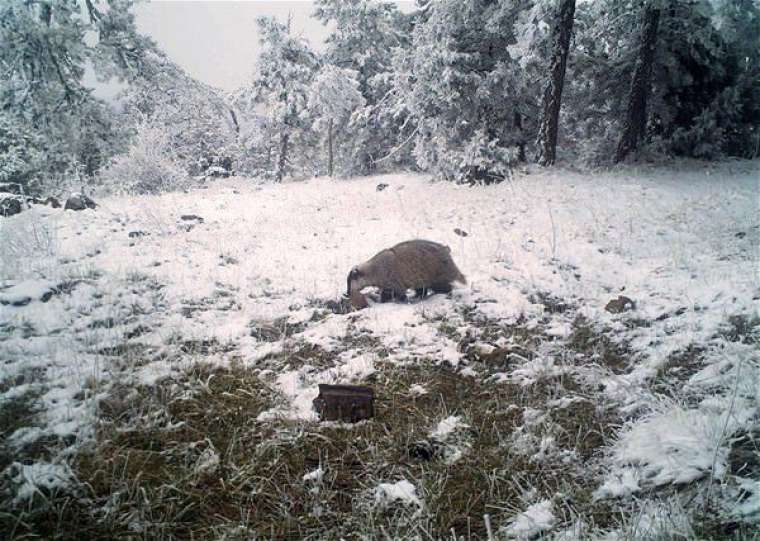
[0,0,153,191]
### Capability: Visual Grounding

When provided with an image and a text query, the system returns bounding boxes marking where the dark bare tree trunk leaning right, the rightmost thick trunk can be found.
[615,4,660,163]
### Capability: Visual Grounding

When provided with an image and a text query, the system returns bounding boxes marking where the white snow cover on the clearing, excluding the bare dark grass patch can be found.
[0,162,760,537]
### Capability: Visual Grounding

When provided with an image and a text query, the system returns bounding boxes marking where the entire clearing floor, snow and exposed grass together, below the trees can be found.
[0,161,760,540]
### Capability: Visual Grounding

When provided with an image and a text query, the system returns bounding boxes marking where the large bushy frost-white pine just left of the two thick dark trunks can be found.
[394,0,523,182]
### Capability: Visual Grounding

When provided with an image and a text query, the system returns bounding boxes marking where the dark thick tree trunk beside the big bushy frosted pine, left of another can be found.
[538,0,575,165]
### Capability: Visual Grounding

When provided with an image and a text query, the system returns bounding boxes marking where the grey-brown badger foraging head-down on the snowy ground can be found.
[346,239,467,308]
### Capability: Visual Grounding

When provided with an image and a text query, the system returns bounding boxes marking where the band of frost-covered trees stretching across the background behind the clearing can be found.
[0,0,760,192]
